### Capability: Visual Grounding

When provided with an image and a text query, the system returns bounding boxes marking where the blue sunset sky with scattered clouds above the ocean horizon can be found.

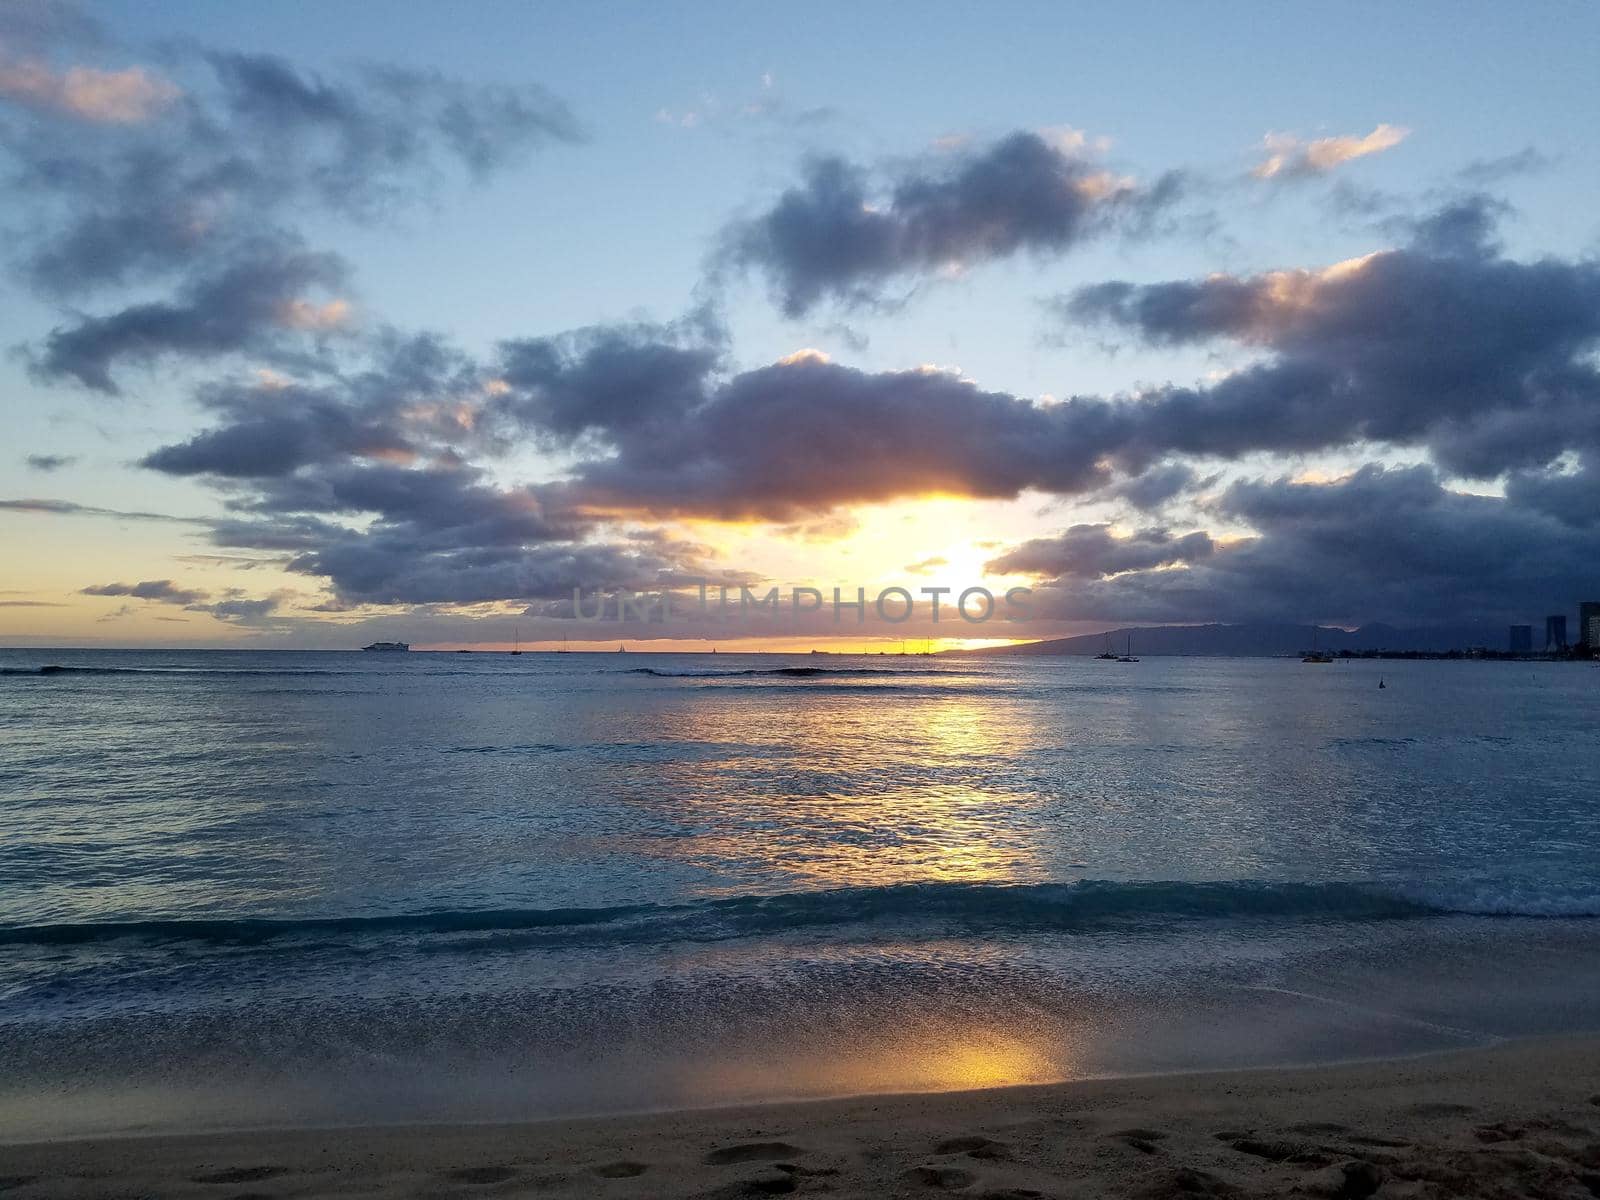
[0,0,1600,650]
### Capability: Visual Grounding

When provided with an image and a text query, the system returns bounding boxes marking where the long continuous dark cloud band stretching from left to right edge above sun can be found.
[146,191,1600,538]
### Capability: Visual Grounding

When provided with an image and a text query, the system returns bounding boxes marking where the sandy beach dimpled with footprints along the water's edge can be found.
[0,1037,1600,1200]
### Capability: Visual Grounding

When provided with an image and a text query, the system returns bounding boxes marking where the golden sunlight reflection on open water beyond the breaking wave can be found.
[627,675,1048,891]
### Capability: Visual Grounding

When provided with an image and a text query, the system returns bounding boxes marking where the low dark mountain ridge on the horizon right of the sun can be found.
[966,624,1506,658]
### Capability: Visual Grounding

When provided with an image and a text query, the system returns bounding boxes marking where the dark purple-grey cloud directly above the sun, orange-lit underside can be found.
[550,347,1123,520]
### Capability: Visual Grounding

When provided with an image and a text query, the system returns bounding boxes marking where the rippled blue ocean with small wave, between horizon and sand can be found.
[0,650,1600,1138]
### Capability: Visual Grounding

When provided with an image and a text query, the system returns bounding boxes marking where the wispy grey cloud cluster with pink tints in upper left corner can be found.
[0,22,582,392]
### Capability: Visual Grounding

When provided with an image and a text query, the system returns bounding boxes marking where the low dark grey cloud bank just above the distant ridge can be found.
[994,466,1600,624]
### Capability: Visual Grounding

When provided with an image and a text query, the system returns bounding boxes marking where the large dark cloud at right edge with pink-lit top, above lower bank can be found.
[1059,198,1600,478]
